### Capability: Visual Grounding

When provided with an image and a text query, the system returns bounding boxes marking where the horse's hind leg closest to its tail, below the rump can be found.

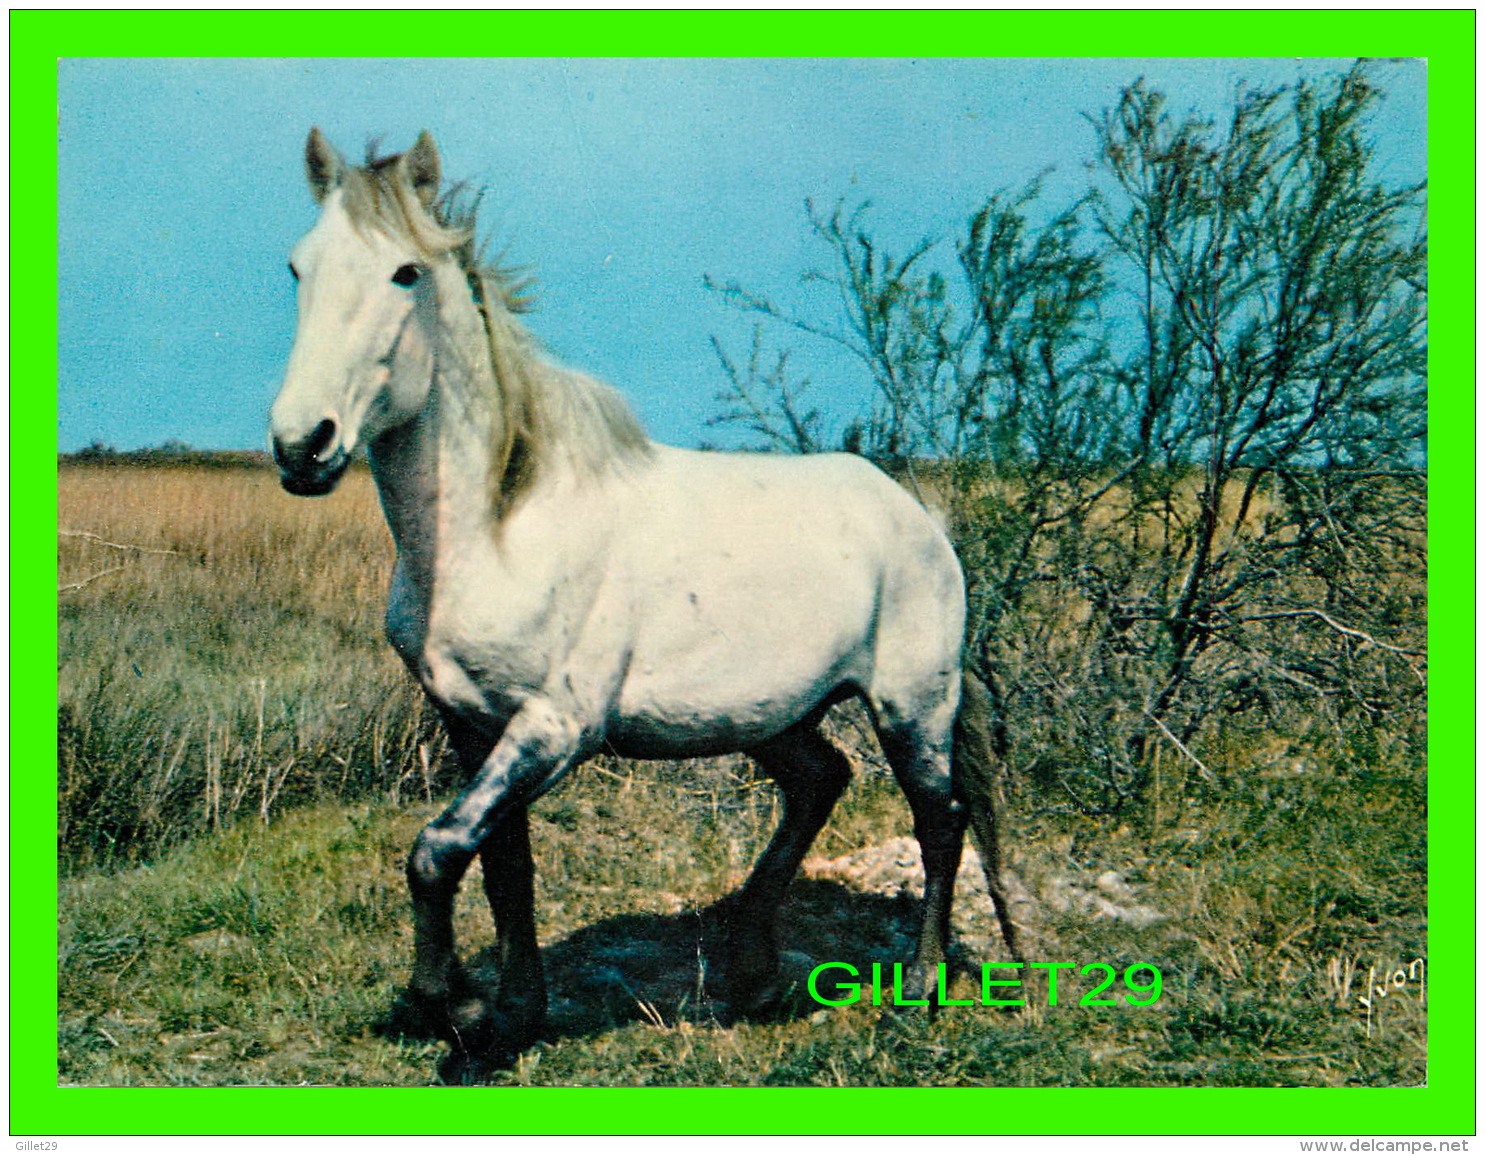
[876,707,968,1007]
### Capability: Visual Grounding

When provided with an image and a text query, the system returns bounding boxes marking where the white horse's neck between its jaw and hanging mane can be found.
[370,296,497,586]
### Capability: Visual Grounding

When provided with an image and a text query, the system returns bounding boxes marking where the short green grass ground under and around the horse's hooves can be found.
[59,748,1426,1087]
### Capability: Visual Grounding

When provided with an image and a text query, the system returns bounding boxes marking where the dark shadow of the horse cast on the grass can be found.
[379,879,919,1082]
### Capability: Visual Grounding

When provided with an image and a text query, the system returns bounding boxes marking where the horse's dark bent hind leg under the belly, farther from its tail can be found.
[728,724,851,1014]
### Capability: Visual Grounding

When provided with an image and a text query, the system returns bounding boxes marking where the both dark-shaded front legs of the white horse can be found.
[407,701,582,1050]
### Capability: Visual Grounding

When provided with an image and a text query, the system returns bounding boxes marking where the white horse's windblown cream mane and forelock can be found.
[340,144,652,515]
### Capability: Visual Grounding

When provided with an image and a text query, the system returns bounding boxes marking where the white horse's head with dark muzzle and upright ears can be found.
[270,129,457,494]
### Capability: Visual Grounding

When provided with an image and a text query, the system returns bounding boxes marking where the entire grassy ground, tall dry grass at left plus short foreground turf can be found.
[58,465,1427,1087]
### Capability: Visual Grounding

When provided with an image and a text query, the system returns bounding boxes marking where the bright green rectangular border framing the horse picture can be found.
[20,10,1476,1136]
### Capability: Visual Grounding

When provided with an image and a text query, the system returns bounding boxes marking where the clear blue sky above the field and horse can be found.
[58,59,1426,450]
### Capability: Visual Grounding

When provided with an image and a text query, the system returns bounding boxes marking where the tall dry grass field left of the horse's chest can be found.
[58,466,440,866]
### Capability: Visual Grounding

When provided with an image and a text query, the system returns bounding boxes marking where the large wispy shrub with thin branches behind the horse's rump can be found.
[713,65,1427,811]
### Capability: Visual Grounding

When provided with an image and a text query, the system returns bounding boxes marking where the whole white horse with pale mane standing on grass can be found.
[272,129,1014,1053]
